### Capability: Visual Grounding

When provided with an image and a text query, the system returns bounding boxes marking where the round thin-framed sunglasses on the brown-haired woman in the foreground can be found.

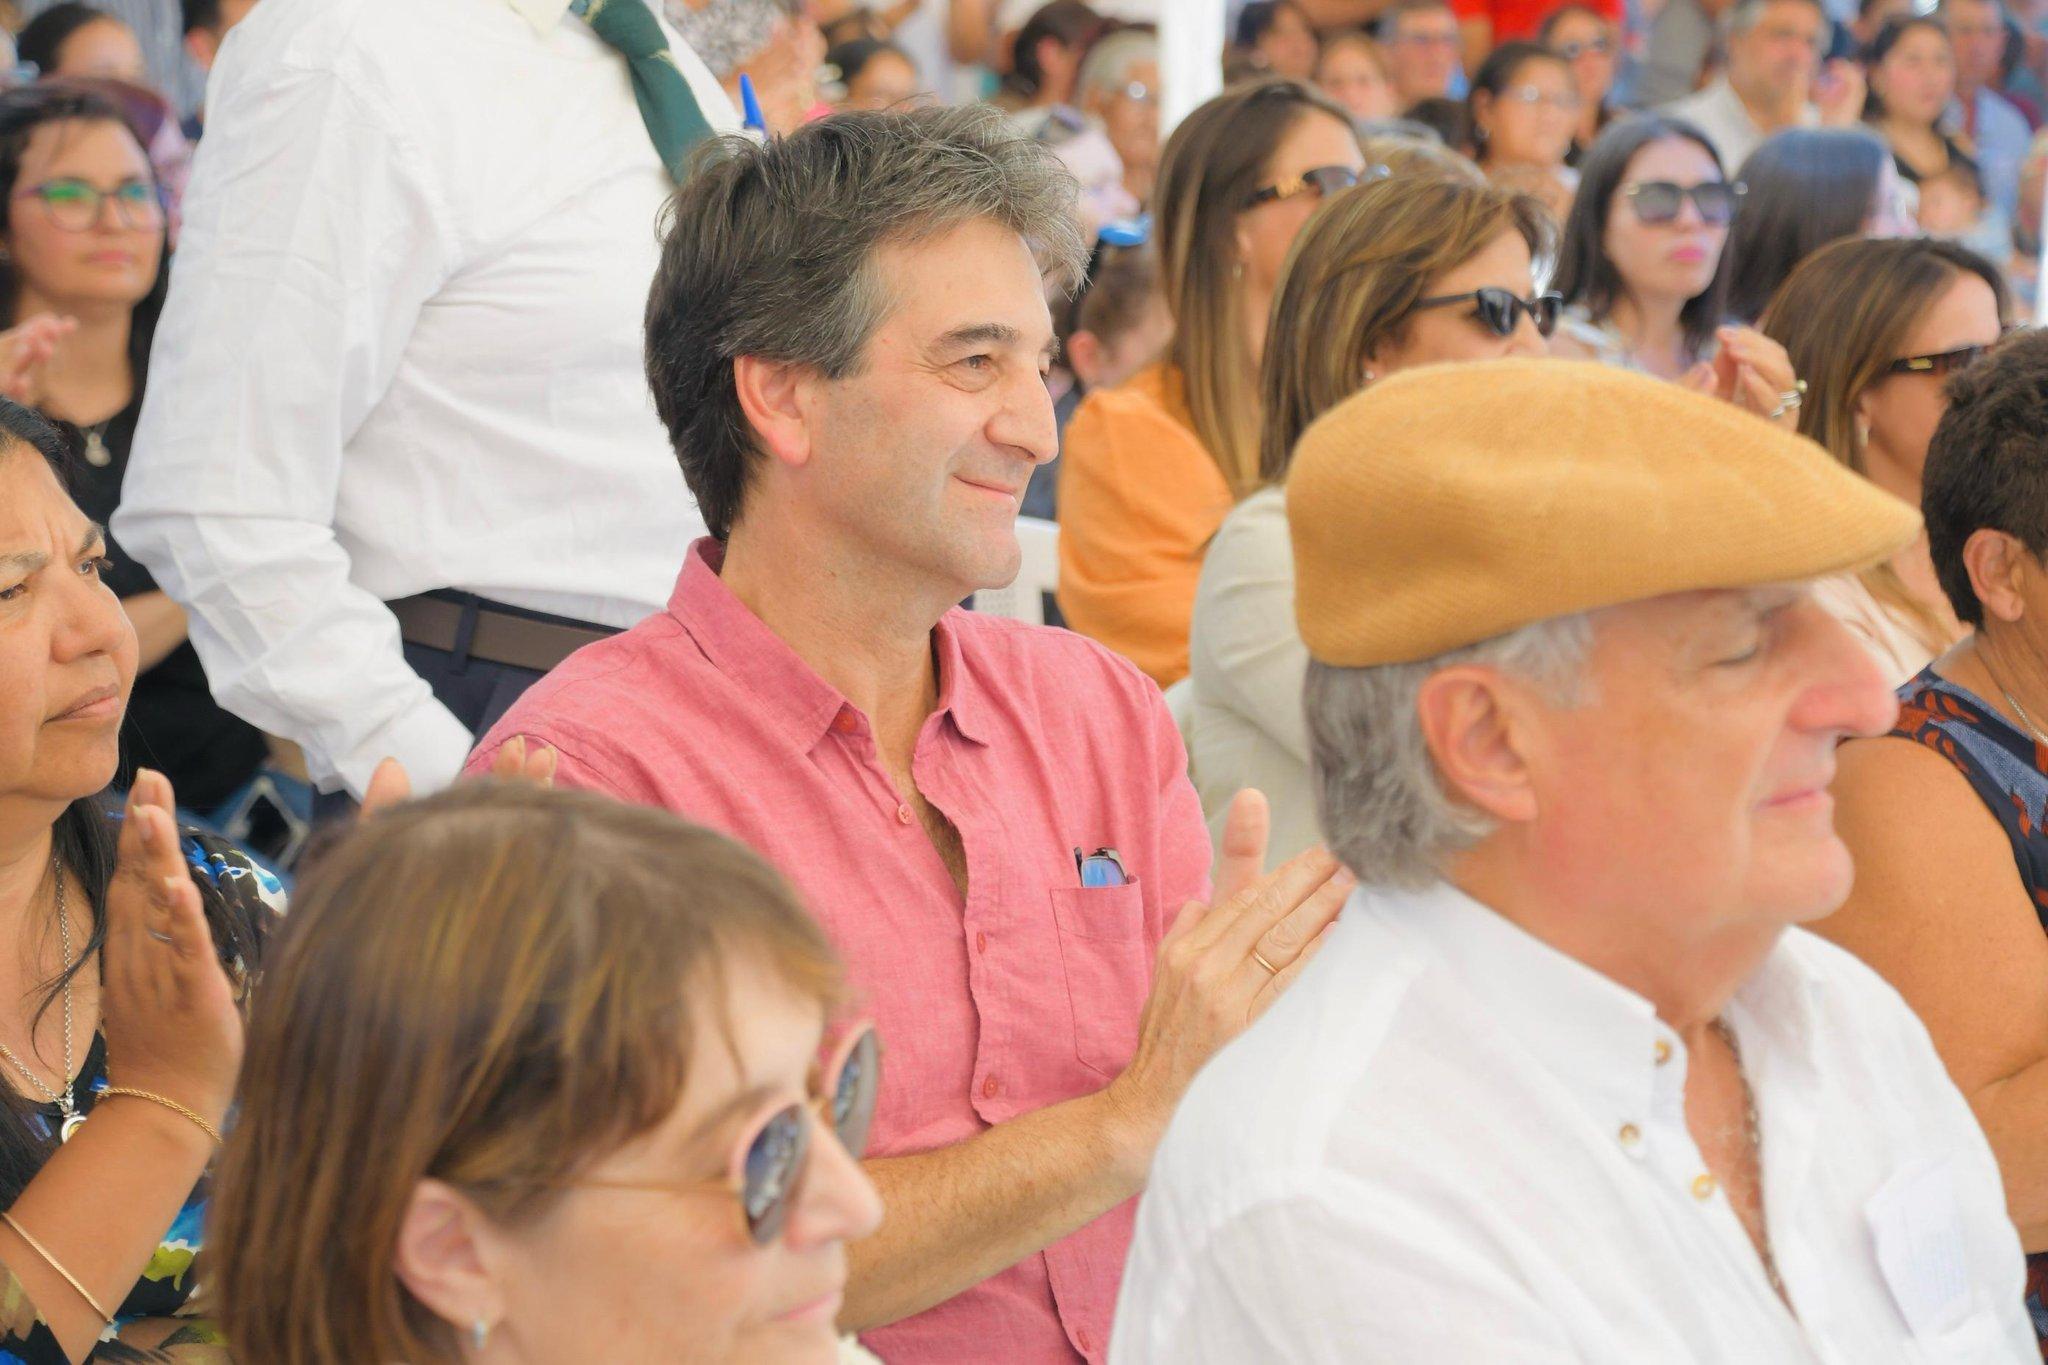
[565,1025,883,1246]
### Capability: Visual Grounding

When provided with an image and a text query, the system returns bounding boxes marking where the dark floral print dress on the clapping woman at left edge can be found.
[0,831,285,1365]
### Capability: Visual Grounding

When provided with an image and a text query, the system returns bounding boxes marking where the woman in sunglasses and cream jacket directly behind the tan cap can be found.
[1184,170,1559,866]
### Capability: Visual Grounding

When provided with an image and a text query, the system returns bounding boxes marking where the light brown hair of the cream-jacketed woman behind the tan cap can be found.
[1260,170,1556,485]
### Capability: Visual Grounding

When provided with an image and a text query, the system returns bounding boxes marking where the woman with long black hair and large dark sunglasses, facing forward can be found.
[1552,117,1800,426]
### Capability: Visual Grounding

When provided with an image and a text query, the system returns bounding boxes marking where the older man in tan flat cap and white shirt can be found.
[1110,360,2040,1365]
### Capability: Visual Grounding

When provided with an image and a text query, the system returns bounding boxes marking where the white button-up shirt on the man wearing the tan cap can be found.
[1110,886,2040,1365]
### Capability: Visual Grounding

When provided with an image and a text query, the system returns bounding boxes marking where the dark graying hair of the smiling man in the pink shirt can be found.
[647,104,1087,540]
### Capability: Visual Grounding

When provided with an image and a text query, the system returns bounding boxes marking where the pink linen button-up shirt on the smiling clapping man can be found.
[469,540,1210,1365]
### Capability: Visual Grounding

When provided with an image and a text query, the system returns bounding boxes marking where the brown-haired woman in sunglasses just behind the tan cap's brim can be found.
[1757,237,2007,686]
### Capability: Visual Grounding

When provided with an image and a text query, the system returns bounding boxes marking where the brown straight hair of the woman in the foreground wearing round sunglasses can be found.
[207,784,840,1365]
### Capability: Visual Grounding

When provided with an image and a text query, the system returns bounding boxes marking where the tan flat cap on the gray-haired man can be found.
[1286,360,1919,667]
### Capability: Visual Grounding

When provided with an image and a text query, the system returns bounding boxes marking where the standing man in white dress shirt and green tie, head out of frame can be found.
[117,0,739,796]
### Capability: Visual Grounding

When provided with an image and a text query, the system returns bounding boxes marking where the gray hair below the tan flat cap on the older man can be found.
[1303,614,1593,888]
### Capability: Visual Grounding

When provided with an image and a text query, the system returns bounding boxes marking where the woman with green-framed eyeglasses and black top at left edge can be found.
[0,84,268,814]
